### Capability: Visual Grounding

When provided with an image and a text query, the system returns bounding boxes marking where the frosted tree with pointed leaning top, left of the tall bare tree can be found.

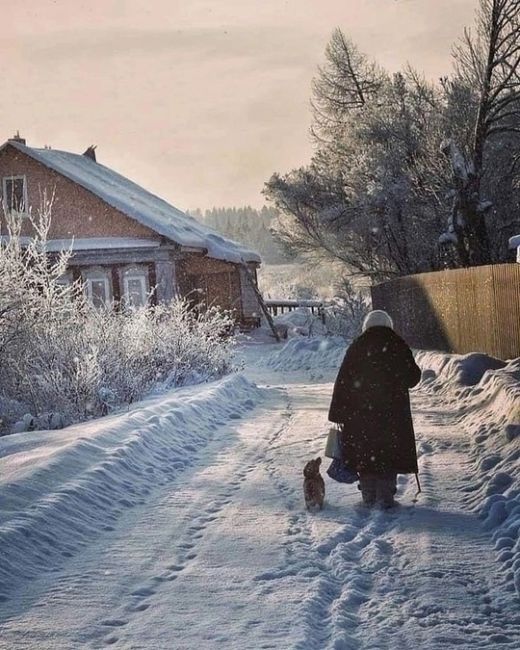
[266,30,448,279]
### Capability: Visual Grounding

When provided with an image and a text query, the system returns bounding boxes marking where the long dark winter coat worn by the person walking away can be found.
[329,327,421,474]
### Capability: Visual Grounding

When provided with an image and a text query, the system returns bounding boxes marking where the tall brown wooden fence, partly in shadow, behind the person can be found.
[371,264,520,359]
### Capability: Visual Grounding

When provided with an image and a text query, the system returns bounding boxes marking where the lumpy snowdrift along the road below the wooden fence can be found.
[417,352,520,595]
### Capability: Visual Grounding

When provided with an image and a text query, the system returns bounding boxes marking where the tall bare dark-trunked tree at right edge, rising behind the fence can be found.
[441,0,520,266]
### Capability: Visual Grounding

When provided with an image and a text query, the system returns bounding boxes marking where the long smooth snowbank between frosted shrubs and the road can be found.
[0,375,261,602]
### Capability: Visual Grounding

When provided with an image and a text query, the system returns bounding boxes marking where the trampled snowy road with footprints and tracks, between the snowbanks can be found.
[0,348,520,650]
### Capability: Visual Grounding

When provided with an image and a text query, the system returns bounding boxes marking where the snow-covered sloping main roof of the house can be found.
[2,140,261,263]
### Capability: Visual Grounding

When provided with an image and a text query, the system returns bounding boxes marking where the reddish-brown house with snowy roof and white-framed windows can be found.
[0,135,260,326]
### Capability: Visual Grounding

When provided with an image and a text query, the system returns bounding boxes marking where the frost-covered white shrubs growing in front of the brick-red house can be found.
[0,209,234,433]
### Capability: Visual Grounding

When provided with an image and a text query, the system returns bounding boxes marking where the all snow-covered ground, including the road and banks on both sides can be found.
[0,339,520,650]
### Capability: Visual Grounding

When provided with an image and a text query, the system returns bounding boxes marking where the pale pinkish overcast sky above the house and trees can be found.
[0,0,477,209]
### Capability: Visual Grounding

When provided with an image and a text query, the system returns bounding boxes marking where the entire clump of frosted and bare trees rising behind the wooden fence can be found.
[265,8,520,280]
